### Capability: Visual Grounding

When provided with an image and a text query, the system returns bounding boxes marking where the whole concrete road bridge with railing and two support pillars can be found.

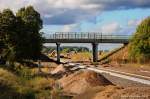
[44,32,131,62]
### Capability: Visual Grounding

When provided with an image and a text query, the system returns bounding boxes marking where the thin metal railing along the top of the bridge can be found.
[45,32,131,39]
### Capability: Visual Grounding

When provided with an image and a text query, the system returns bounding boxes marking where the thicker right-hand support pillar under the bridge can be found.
[92,43,98,62]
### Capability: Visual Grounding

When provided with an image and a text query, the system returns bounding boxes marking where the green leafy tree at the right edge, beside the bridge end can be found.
[129,17,150,62]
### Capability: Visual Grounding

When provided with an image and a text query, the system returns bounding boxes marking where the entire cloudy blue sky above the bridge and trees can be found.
[0,0,150,49]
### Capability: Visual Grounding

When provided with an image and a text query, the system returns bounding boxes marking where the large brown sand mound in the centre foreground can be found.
[58,70,112,94]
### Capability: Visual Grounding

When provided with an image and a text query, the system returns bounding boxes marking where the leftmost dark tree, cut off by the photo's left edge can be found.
[0,9,16,61]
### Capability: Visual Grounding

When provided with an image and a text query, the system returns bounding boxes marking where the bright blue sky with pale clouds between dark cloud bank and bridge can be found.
[42,8,150,35]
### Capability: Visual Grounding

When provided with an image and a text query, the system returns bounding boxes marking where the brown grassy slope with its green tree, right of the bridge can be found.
[104,17,150,64]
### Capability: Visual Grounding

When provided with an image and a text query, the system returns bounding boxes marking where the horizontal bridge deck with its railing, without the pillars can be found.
[44,33,130,43]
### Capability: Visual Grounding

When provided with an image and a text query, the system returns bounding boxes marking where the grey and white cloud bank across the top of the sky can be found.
[0,0,150,25]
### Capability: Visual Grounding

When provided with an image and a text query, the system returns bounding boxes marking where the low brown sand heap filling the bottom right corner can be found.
[73,86,150,99]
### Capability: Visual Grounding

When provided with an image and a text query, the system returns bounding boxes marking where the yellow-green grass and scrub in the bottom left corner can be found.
[0,64,68,99]
